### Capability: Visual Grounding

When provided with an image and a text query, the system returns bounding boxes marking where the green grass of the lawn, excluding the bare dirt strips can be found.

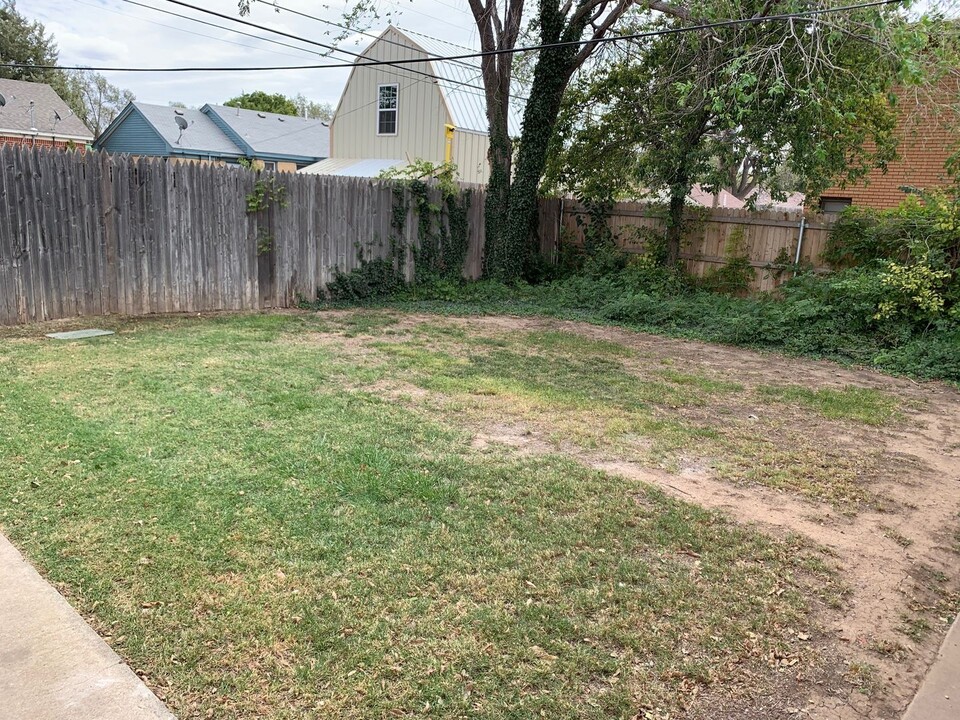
[0,315,848,718]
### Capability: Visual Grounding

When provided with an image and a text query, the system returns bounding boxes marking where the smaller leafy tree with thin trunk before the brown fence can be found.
[548,5,923,263]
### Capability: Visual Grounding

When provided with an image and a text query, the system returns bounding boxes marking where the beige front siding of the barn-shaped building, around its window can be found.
[330,28,452,162]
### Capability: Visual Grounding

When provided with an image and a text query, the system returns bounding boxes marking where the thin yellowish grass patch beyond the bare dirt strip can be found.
[365,320,899,513]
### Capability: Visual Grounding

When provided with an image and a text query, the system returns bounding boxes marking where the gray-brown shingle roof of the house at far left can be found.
[0,78,93,141]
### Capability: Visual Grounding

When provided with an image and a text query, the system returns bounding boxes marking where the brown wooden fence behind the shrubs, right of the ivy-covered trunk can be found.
[540,199,836,291]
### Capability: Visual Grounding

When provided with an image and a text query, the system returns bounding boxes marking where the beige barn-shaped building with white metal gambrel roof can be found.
[302,26,519,183]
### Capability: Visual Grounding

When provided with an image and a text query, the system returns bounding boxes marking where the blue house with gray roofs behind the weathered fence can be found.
[94,102,330,172]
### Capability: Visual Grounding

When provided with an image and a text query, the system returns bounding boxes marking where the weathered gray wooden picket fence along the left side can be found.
[0,145,483,324]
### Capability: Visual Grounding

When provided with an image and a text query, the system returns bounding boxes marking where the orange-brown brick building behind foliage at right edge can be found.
[820,78,960,212]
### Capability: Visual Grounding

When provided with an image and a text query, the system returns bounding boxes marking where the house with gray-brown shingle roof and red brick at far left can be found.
[0,78,93,148]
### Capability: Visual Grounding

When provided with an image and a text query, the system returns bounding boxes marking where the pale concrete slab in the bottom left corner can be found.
[0,535,176,720]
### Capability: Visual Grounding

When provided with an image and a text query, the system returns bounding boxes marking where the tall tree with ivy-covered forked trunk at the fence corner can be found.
[240,0,932,279]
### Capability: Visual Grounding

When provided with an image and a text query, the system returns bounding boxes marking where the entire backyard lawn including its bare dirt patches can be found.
[0,311,960,719]
